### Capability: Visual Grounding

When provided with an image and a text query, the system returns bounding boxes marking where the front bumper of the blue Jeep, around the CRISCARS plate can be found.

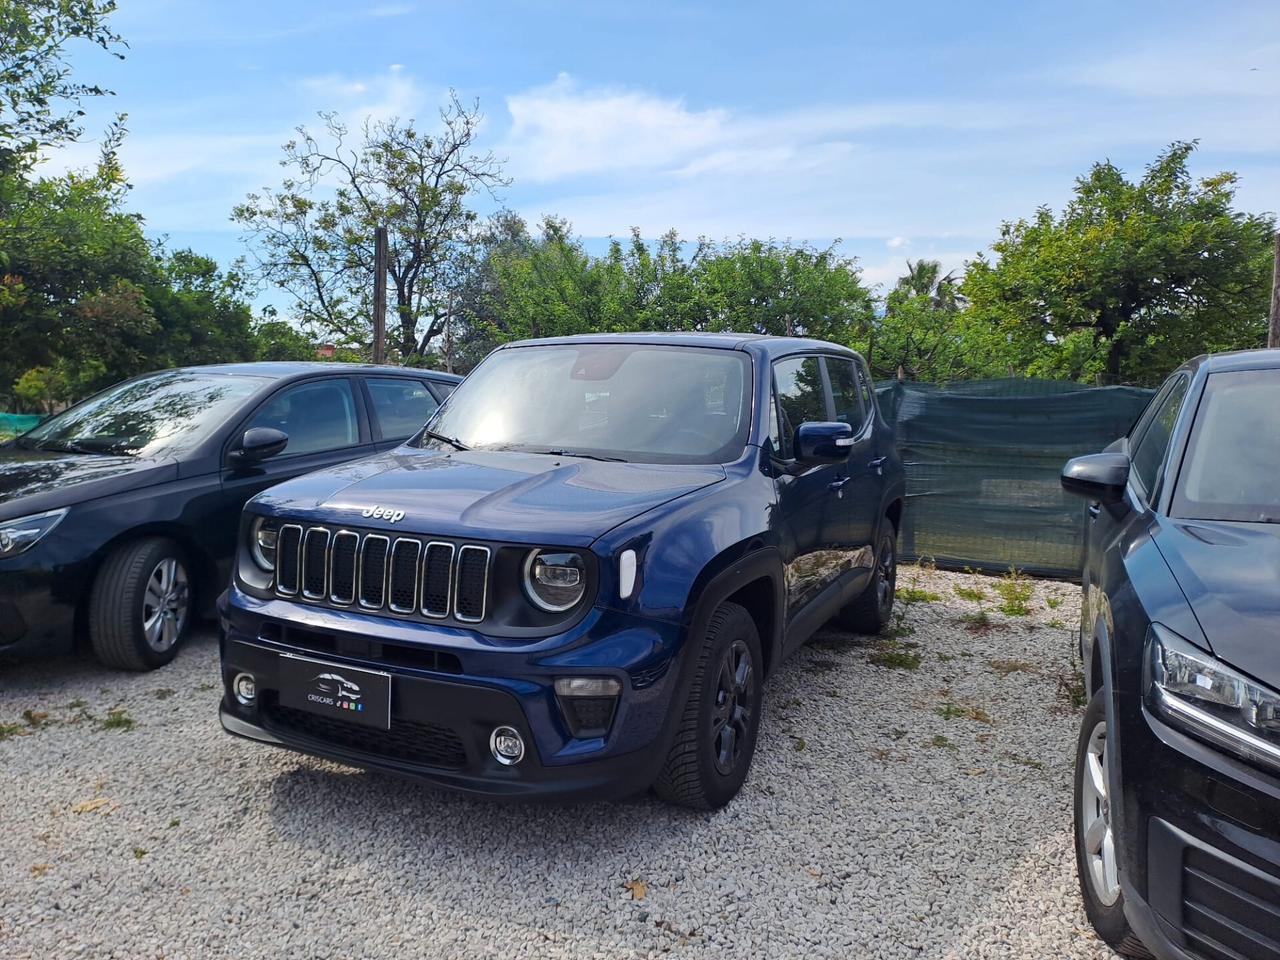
[219,588,684,799]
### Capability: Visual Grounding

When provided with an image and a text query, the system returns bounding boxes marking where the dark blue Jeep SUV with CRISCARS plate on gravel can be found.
[220,334,902,808]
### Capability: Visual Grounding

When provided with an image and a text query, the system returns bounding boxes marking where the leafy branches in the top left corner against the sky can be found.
[0,0,124,169]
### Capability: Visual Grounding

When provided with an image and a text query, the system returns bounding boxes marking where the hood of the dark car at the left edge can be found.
[0,443,178,520]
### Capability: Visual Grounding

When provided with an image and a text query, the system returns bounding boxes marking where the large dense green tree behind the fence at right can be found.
[961,143,1275,384]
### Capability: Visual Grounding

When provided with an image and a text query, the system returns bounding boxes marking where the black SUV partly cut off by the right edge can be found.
[1062,351,1280,960]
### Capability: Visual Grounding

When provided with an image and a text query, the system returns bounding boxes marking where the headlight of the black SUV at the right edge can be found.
[1146,625,1280,771]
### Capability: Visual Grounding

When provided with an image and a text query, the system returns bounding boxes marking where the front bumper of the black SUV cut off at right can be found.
[1120,698,1280,960]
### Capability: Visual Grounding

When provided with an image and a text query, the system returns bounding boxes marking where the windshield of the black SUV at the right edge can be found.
[1172,370,1280,524]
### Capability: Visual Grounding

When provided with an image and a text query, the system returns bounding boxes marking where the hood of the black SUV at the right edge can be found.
[1156,520,1280,687]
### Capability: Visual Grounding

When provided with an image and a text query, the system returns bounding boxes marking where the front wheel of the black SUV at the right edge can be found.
[1075,690,1151,957]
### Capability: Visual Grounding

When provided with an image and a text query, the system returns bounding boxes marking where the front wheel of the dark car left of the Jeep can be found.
[88,538,192,669]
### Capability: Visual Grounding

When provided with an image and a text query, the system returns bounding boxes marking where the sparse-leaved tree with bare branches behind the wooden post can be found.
[232,93,507,360]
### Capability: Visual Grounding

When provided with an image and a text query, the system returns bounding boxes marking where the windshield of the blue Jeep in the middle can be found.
[417,343,750,463]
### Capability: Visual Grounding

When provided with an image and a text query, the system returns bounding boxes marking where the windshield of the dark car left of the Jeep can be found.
[17,370,268,457]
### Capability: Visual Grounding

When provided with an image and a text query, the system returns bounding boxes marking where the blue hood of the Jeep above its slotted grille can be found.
[253,447,726,547]
